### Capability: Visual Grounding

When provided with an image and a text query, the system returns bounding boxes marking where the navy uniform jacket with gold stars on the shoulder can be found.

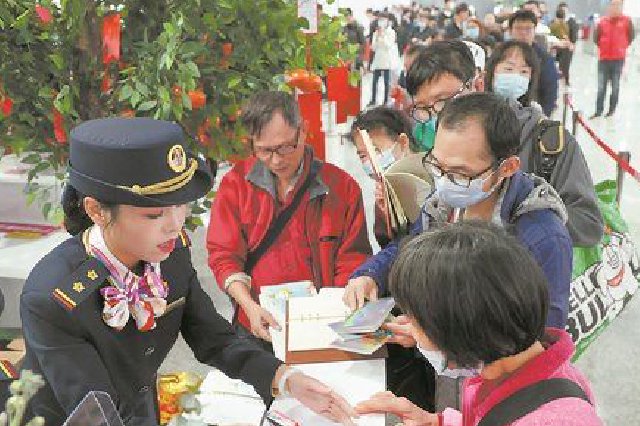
[20,236,281,426]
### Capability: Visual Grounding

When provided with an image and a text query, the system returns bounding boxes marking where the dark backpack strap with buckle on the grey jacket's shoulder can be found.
[533,118,565,182]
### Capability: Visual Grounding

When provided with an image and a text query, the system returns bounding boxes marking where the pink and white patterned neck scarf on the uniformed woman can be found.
[87,226,168,331]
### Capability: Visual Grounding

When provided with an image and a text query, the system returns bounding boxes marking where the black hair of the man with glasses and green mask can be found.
[407,40,476,96]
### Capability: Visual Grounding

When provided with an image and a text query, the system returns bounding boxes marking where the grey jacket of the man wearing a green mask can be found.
[511,102,604,247]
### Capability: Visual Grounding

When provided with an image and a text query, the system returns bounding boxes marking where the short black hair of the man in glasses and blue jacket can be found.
[438,92,520,160]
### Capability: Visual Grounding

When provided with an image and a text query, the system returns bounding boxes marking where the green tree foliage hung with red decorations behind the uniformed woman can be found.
[0,0,356,225]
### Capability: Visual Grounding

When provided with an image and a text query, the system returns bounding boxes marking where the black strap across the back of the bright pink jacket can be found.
[478,379,591,426]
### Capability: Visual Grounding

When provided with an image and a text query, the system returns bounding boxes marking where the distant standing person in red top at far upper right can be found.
[590,0,635,118]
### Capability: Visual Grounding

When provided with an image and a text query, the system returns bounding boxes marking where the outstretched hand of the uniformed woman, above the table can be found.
[286,372,357,426]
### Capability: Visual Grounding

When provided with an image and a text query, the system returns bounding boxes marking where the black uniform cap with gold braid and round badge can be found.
[69,118,213,207]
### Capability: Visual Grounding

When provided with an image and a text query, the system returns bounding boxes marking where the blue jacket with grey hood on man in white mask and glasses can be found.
[352,172,573,328]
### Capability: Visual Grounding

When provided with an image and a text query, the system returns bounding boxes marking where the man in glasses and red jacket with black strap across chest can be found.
[207,92,371,340]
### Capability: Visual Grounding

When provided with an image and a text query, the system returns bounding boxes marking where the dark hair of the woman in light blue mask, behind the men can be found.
[485,40,540,106]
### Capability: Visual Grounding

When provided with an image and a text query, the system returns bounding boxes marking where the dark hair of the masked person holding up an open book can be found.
[350,106,420,152]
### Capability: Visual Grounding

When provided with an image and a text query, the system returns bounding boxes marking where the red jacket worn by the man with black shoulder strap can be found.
[207,149,371,326]
